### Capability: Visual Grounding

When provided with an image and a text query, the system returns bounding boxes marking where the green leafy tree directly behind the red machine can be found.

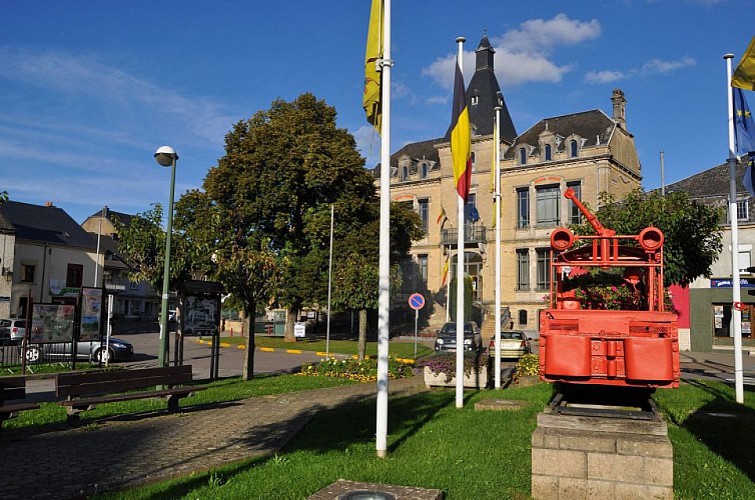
[574,189,723,286]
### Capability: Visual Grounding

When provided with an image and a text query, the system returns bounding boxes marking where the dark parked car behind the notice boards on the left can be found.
[26,337,134,363]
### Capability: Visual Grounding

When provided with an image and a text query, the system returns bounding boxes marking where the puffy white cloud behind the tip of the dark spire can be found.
[422,14,601,89]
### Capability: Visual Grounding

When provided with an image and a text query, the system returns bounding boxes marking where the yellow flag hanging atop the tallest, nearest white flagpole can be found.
[362,0,383,134]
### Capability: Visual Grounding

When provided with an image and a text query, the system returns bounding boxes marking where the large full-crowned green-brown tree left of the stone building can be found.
[204,93,375,341]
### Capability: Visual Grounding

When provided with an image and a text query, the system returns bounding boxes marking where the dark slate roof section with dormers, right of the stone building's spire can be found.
[503,109,616,160]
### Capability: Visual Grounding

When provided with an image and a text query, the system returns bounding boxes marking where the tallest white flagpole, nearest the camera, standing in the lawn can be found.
[375,0,393,458]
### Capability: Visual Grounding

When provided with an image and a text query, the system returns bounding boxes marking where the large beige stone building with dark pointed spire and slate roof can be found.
[374,36,642,336]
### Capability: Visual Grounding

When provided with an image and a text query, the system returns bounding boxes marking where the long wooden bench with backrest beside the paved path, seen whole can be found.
[55,365,207,425]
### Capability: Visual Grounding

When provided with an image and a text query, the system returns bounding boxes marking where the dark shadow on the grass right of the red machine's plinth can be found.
[675,380,755,481]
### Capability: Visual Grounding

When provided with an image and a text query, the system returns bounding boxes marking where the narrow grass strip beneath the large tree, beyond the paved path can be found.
[220,335,434,359]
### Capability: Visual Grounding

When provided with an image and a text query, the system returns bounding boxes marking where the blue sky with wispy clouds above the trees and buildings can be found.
[0,0,755,222]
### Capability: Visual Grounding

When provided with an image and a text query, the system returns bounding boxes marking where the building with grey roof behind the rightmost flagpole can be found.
[665,162,755,352]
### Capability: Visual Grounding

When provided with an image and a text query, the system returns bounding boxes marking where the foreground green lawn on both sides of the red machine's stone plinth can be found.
[85,377,755,499]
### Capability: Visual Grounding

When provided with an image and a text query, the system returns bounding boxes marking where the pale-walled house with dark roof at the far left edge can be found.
[0,201,97,317]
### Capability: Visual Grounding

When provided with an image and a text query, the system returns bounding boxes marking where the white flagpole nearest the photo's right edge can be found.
[724,54,744,403]
